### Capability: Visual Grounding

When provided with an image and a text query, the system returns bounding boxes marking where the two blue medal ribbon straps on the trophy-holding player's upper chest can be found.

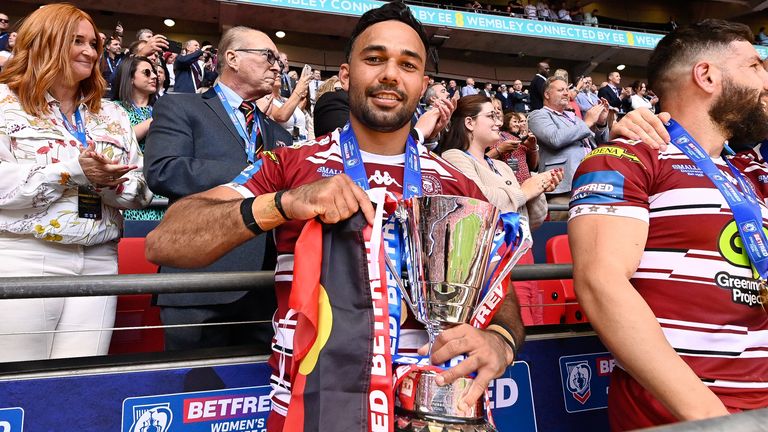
[339,123,421,199]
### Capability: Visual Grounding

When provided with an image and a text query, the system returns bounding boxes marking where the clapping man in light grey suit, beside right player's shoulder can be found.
[528,77,608,220]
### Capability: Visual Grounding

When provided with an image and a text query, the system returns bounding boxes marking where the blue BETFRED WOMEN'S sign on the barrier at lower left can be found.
[121,386,271,432]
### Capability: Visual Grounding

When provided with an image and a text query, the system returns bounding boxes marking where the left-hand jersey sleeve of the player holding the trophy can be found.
[226,149,290,198]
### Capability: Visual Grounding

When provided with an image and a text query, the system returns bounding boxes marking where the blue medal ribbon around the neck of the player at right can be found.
[666,119,768,281]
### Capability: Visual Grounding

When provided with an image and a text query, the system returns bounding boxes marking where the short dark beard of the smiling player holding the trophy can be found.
[349,84,418,132]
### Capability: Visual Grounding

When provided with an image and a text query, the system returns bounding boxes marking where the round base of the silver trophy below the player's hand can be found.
[395,370,496,432]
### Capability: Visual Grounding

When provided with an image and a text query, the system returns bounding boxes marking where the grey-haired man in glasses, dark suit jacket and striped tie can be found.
[144,27,293,351]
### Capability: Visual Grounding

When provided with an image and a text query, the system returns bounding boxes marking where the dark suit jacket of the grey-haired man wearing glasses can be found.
[144,89,293,306]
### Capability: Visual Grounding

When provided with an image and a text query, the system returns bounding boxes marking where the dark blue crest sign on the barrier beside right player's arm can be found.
[560,353,615,413]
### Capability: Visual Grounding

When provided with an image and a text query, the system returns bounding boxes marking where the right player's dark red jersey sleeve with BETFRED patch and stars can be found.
[569,143,656,223]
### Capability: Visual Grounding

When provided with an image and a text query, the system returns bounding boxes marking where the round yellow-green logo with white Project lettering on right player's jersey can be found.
[715,220,768,307]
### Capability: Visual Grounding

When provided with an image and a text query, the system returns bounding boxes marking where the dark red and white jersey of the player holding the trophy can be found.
[228,130,486,426]
